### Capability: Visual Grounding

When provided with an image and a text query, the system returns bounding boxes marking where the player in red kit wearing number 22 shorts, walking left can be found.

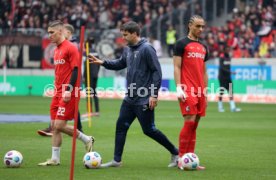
[38,20,94,166]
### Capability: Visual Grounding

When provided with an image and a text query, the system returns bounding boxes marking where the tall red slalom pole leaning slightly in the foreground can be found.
[70,26,85,180]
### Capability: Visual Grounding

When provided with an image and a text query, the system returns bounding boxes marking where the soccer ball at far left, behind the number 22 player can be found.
[4,150,23,167]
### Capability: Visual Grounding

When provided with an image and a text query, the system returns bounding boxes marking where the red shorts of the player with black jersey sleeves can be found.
[179,92,207,116]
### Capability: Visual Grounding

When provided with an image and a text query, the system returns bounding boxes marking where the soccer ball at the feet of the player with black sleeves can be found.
[178,153,199,170]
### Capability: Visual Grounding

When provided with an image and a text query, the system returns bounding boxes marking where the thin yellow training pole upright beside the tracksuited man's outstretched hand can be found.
[85,42,92,127]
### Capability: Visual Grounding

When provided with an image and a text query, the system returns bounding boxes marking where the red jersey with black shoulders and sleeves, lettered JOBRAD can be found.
[174,37,208,93]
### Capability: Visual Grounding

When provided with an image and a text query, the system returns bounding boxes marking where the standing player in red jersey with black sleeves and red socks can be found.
[173,15,208,170]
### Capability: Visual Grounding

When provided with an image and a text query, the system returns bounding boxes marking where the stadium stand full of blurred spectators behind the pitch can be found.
[0,0,276,58]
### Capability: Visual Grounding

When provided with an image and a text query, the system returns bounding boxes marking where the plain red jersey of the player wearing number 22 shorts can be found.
[54,40,81,97]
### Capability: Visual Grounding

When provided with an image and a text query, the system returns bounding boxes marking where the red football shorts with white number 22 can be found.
[50,96,76,120]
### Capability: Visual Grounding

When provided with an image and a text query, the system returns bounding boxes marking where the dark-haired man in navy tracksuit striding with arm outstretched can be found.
[88,21,178,167]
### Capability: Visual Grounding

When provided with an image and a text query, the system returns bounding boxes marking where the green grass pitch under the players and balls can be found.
[0,96,276,180]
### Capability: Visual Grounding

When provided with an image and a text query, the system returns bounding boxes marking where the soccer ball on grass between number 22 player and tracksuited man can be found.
[83,151,102,169]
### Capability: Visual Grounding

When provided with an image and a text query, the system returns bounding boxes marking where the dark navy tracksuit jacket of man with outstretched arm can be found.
[102,38,162,105]
